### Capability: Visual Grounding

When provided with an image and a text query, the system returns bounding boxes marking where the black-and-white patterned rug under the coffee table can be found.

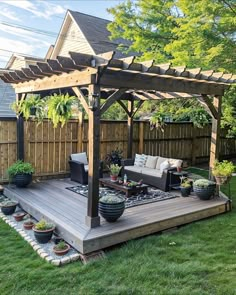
[66,184,178,208]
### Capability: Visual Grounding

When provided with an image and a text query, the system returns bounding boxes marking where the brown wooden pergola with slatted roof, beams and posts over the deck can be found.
[0,52,236,228]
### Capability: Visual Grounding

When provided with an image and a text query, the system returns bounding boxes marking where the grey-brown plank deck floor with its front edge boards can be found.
[5,179,230,254]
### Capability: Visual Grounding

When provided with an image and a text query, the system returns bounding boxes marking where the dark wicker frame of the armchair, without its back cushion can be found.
[69,156,103,184]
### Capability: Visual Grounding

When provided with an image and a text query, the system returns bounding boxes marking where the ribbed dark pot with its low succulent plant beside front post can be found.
[99,195,125,222]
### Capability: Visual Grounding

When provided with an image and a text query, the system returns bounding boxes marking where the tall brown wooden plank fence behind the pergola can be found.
[0,118,236,180]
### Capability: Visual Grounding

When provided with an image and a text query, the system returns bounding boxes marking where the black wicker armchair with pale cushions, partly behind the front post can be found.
[69,153,103,184]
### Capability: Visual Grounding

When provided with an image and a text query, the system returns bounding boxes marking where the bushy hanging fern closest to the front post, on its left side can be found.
[47,93,75,128]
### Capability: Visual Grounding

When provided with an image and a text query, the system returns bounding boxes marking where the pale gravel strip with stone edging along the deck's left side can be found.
[0,207,80,266]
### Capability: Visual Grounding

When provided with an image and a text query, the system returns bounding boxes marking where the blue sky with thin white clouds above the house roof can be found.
[0,0,125,68]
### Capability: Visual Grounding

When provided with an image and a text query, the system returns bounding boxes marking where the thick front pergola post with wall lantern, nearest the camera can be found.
[85,84,100,228]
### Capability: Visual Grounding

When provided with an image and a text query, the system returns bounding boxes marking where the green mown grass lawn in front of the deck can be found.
[0,170,236,295]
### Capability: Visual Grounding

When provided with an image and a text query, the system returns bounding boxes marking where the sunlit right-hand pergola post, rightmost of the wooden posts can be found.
[209,96,222,177]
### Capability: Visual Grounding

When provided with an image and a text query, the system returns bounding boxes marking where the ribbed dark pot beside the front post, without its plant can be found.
[99,200,125,222]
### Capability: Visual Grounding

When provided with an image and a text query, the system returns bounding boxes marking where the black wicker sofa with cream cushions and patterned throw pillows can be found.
[122,154,183,192]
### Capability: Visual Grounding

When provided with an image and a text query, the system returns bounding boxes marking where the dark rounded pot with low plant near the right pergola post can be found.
[193,179,216,200]
